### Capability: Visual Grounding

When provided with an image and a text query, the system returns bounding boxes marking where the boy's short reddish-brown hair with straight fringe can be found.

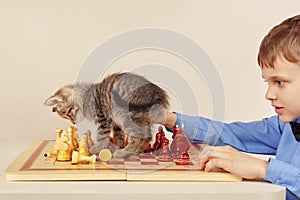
[257,15,300,68]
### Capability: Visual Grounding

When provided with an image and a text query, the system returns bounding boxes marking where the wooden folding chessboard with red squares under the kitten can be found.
[6,140,242,181]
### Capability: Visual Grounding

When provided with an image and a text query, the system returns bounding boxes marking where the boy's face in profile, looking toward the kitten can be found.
[262,57,300,122]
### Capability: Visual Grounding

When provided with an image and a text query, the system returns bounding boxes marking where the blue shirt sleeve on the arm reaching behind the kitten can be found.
[172,113,285,154]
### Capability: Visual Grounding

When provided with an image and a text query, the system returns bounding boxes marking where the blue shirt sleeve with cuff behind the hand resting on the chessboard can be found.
[265,158,300,197]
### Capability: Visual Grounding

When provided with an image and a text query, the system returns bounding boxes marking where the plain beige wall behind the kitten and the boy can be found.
[0,0,300,143]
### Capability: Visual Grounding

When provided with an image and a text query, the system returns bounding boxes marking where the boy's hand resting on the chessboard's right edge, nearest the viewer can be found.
[200,145,269,179]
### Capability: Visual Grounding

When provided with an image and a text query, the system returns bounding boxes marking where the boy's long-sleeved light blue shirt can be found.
[176,113,300,199]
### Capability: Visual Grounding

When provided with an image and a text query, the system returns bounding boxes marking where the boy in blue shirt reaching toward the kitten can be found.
[164,15,300,199]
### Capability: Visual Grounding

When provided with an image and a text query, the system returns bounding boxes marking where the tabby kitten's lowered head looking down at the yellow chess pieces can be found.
[44,85,80,124]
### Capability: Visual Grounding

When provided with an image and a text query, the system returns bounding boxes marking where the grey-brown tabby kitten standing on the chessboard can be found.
[44,73,169,158]
